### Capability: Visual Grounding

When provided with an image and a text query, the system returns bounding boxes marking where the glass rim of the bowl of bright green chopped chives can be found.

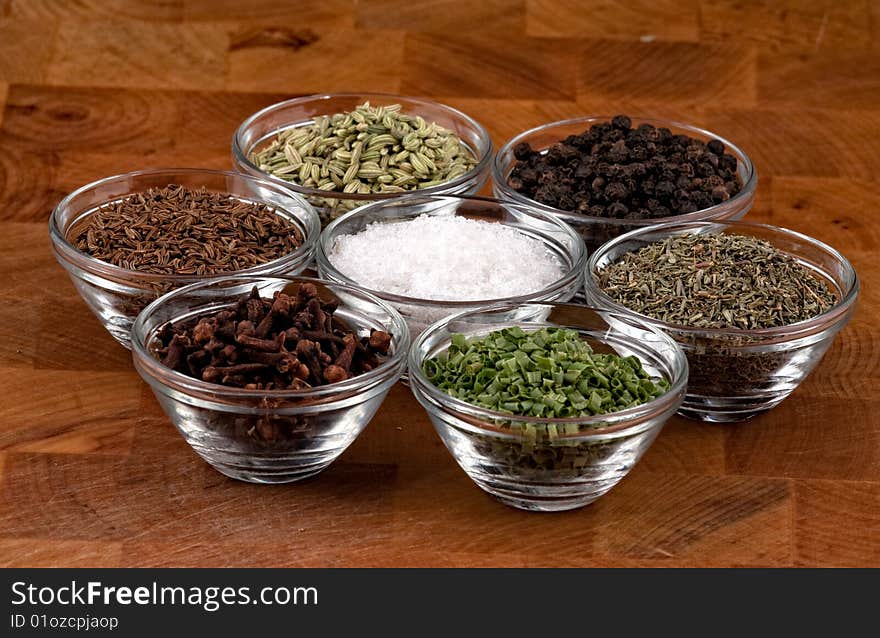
[407,302,689,440]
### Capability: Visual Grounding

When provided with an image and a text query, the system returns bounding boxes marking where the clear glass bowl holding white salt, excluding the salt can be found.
[315,195,587,335]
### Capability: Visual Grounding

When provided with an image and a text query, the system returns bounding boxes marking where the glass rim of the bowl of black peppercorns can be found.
[492,115,758,226]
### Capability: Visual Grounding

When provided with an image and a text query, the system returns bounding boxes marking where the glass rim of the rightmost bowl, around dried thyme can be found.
[584,220,860,340]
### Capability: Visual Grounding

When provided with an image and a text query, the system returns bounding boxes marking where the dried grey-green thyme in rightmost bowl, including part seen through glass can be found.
[596,233,836,415]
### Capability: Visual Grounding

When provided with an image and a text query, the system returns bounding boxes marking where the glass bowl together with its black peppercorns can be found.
[492,115,758,252]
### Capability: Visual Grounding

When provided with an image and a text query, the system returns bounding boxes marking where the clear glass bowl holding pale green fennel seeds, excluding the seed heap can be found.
[232,93,492,225]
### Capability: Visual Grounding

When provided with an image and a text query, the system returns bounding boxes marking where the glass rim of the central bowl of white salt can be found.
[315,193,587,309]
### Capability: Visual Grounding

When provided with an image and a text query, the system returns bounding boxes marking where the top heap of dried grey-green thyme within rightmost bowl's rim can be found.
[597,233,835,330]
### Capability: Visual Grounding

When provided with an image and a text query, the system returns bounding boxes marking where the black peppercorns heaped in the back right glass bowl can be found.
[508,115,742,219]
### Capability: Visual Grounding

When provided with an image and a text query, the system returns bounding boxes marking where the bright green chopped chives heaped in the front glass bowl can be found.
[423,327,669,422]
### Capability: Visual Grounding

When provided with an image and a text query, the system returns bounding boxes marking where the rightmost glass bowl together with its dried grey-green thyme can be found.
[585,221,859,422]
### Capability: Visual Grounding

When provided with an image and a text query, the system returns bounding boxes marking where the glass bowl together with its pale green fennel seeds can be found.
[232,93,492,226]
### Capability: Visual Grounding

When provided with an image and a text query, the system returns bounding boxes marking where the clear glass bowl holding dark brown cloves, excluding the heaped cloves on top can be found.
[132,276,409,483]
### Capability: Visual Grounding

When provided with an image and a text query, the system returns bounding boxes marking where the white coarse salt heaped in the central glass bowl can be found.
[329,215,564,301]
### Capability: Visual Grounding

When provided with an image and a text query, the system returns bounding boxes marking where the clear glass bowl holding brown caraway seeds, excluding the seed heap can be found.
[49,168,321,348]
